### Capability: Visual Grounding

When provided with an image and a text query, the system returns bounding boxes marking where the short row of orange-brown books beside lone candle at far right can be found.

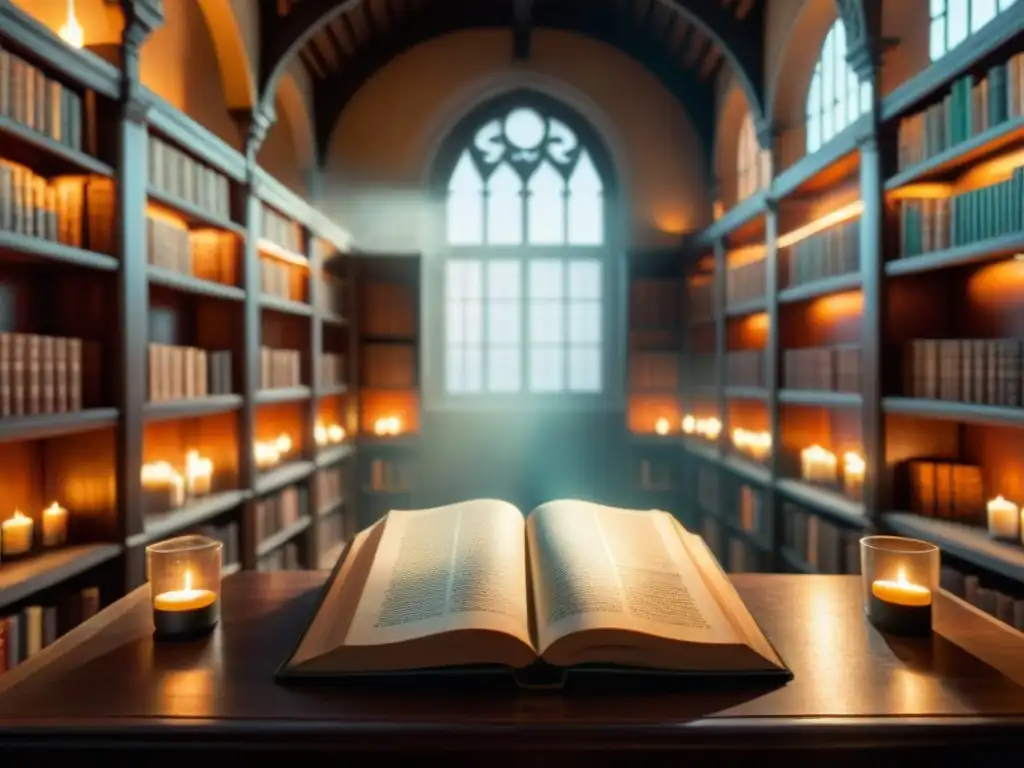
[905,459,985,524]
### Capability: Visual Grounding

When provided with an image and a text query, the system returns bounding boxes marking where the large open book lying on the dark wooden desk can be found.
[279,500,791,679]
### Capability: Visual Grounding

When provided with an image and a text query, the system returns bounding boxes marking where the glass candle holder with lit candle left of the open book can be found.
[145,536,223,640]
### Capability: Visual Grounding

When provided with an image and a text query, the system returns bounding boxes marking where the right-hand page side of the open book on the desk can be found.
[527,501,741,652]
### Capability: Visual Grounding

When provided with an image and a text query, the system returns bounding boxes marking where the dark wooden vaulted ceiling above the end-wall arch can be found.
[261,0,764,163]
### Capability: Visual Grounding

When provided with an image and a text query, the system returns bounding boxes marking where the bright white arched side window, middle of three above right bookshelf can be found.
[807,18,871,154]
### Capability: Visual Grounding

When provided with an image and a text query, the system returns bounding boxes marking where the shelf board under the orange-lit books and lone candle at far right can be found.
[882,512,1024,582]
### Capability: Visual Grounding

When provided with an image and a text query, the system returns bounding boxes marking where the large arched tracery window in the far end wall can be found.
[444,99,606,396]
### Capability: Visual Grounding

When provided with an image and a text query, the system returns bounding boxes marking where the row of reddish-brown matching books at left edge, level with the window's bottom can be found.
[0,333,92,416]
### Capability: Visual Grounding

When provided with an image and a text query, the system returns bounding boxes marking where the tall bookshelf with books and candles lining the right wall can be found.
[681,30,1024,629]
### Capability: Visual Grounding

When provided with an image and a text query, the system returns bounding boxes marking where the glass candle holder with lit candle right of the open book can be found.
[860,536,940,636]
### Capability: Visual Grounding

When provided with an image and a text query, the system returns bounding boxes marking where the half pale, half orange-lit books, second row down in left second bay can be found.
[145,215,239,286]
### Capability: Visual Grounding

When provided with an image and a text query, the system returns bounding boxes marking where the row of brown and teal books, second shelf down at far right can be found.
[899,168,1024,258]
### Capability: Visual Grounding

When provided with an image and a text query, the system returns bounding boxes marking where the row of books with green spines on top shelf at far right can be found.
[898,53,1024,170]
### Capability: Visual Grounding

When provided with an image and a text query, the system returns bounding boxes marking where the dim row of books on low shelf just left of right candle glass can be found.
[782,502,863,574]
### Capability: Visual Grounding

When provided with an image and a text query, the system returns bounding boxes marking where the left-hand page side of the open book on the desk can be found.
[345,500,532,647]
